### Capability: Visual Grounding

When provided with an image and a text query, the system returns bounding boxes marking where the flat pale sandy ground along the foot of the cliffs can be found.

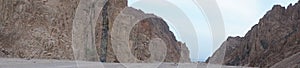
[0,58,258,68]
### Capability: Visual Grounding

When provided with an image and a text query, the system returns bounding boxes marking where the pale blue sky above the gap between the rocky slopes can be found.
[128,0,297,61]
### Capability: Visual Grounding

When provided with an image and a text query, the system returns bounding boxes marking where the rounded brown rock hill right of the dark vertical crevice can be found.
[108,7,190,62]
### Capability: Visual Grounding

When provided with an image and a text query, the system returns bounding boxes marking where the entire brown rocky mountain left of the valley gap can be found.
[0,0,190,62]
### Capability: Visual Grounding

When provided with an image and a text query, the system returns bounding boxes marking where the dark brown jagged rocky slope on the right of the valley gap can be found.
[212,3,300,68]
